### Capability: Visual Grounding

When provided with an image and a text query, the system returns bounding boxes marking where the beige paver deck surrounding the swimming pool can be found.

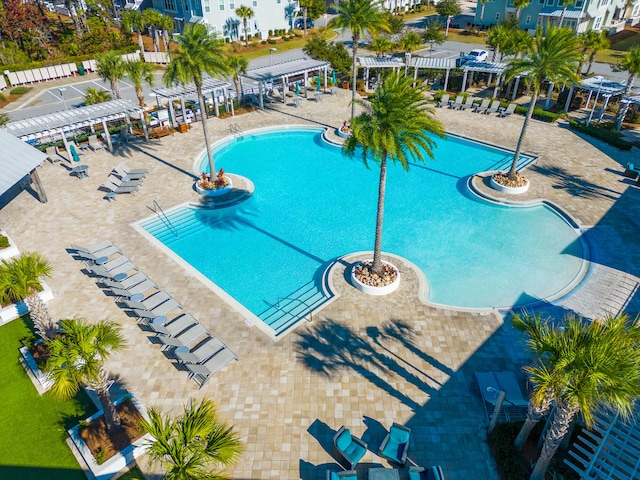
[0,90,640,480]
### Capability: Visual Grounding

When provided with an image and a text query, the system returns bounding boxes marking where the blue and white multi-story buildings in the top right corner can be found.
[475,0,640,34]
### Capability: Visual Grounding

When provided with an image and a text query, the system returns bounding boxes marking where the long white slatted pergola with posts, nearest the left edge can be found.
[6,100,149,152]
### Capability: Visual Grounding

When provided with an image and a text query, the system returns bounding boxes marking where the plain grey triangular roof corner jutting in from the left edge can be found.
[0,128,47,195]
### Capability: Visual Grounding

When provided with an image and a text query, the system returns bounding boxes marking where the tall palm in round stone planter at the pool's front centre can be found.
[344,72,444,280]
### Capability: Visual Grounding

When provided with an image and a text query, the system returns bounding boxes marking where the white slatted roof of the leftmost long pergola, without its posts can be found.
[6,100,142,138]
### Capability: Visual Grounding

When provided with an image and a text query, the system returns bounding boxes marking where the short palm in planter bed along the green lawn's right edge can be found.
[44,318,125,432]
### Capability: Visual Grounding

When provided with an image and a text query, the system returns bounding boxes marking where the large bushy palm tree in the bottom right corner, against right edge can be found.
[514,315,640,480]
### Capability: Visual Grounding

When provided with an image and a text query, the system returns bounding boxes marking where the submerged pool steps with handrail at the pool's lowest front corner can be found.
[258,281,328,336]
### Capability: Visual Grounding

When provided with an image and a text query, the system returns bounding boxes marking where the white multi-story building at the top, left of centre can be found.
[153,0,299,41]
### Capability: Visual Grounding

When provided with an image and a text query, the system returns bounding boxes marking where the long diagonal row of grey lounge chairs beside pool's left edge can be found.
[70,240,238,387]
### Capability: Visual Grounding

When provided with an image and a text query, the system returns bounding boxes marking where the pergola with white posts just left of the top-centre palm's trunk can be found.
[245,58,330,110]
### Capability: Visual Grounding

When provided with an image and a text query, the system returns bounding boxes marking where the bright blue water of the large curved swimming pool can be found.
[142,129,583,332]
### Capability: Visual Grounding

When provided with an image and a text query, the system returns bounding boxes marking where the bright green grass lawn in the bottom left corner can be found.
[0,319,95,480]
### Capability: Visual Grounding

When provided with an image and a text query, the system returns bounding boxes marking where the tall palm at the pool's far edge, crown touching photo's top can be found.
[329,0,388,119]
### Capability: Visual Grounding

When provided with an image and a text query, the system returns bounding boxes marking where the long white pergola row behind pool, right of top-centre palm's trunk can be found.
[358,53,506,97]
